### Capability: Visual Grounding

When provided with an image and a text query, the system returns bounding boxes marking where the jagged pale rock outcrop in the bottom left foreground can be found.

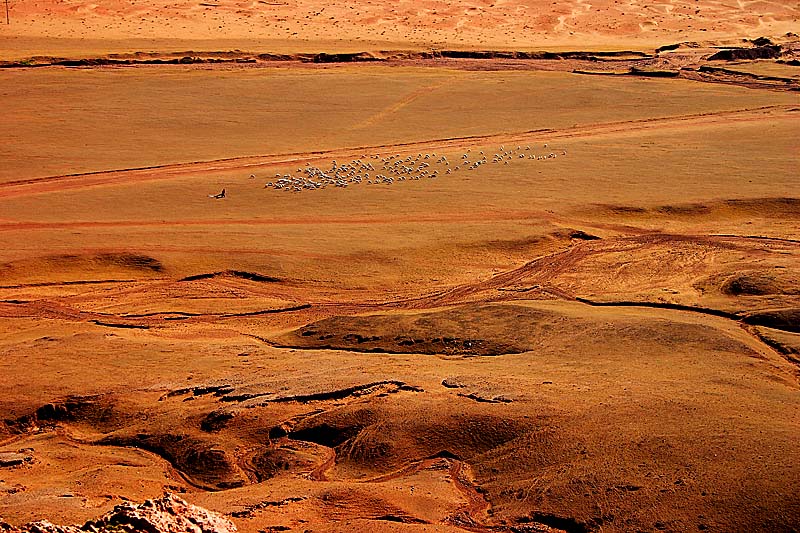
[0,494,236,533]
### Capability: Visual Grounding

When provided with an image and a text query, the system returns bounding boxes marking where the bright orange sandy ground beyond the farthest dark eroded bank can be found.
[0,0,800,53]
